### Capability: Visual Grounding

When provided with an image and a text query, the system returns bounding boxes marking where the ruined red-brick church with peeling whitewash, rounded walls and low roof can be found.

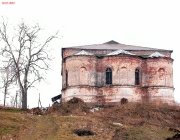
[62,40,174,105]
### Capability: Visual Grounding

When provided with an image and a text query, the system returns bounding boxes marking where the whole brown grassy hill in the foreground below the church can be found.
[0,101,180,140]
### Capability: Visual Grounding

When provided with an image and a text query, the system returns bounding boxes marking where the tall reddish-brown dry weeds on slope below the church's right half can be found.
[97,103,180,127]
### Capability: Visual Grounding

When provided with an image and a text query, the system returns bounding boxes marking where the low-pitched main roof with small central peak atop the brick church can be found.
[64,40,172,51]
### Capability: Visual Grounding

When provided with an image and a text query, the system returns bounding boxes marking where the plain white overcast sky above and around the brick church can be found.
[0,0,180,107]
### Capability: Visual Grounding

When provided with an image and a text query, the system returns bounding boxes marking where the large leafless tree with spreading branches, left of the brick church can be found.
[0,20,58,110]
